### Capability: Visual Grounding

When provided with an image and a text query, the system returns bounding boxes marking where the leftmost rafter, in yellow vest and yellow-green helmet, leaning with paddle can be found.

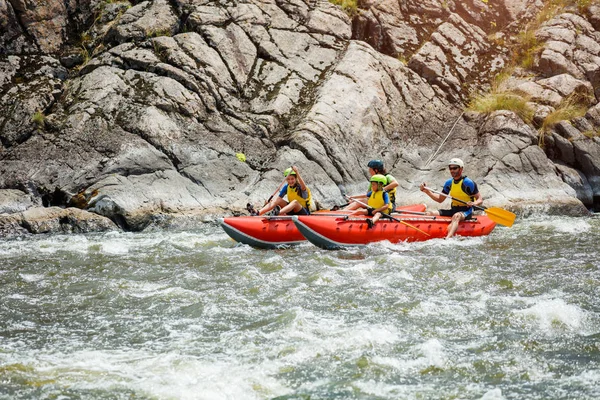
[258,166,312,215]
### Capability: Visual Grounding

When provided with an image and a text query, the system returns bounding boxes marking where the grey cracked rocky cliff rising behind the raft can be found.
[0,0,600,232]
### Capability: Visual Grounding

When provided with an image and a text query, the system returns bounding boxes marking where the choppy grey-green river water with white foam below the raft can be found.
[0,217,600,400]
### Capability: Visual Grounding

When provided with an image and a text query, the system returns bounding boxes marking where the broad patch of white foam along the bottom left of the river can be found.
[24,349,289,400]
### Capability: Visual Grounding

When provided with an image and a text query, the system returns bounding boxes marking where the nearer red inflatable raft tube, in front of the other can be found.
[293,215,496,250]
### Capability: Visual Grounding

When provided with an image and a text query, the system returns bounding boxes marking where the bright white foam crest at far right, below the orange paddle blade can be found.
[515,299,586,332]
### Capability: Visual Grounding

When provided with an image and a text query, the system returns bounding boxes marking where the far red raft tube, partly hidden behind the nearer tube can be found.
[219,204,426,249]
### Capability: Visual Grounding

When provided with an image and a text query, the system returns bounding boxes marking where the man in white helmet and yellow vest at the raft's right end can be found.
[419,158,483,239]
